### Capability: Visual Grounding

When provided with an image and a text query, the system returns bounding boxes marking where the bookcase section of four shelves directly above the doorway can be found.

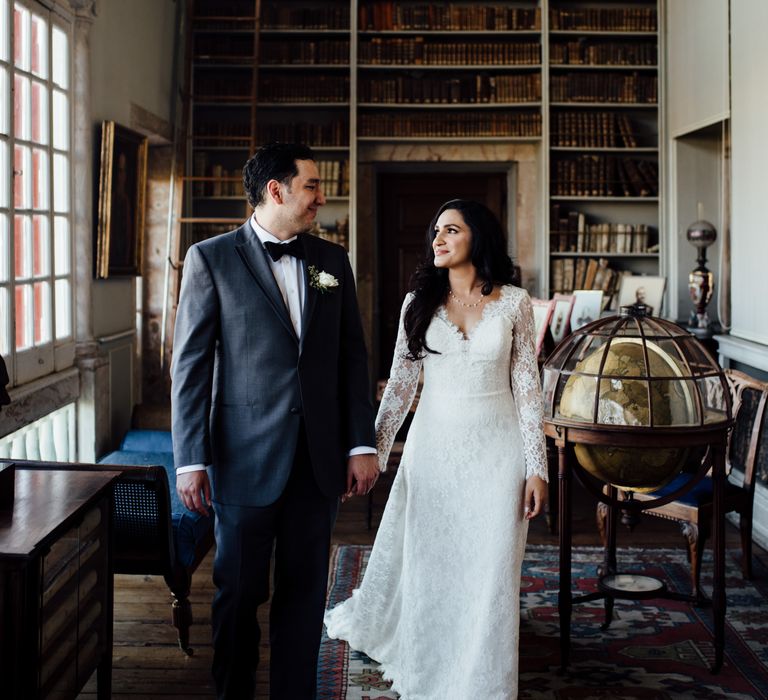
[357,0,541,141]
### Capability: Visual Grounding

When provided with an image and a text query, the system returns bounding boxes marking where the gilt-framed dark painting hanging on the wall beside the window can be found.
[96,121,147,278]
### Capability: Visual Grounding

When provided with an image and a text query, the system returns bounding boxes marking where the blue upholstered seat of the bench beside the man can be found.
[99,440,213,567]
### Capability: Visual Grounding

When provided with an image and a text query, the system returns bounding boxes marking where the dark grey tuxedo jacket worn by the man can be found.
[171,222,376,506]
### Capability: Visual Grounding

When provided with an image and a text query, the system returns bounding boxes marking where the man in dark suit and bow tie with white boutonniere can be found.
[172,143,378,700]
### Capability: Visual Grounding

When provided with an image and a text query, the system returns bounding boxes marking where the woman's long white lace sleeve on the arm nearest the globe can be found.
[511,292,548,481]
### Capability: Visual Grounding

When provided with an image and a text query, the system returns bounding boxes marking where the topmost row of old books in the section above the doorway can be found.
[359,0,541,32]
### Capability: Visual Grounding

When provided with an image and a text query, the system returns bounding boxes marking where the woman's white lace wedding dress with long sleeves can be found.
[325,286,547,700]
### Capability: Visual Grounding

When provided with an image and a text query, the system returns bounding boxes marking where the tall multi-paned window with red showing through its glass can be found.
[0,0,74,384]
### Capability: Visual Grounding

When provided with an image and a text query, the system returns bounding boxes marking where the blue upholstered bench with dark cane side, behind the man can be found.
[99,430,213,654]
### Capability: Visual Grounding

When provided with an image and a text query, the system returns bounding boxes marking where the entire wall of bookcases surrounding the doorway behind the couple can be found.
[182,0,663,306]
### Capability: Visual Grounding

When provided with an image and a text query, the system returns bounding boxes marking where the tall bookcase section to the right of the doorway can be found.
[546,0,660,304]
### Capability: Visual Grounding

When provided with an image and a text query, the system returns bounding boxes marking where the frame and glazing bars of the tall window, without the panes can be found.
[0,0,77,387]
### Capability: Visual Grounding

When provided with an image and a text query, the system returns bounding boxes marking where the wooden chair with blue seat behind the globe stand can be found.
[597,370,768,601]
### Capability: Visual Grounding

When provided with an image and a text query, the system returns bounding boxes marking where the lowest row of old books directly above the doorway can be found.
[358,112,541,138]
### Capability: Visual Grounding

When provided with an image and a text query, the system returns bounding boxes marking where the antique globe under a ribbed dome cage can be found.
[543,304,731,492]
